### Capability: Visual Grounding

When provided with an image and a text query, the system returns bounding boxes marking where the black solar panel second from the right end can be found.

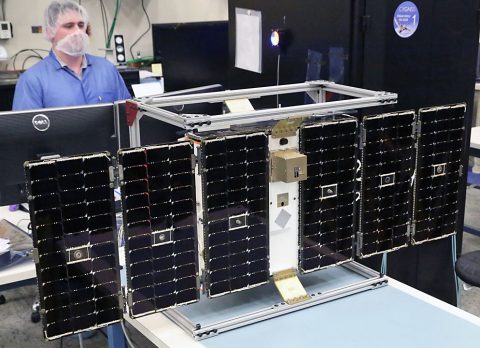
[359,111,415,257]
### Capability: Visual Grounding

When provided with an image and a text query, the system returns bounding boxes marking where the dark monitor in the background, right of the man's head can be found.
[152,21,228,92]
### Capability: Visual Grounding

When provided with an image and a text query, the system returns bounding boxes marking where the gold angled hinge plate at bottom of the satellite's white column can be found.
[273,268,310,305]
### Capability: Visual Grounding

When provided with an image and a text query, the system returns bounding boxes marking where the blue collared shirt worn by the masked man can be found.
[13,51,131,110]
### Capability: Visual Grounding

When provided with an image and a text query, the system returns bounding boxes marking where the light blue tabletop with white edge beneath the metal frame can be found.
[124,279,480,348]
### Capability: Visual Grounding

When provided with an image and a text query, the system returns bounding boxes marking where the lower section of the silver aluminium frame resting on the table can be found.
[163,262,388,340]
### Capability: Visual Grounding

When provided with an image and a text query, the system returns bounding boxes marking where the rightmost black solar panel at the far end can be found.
[412,104,466,244]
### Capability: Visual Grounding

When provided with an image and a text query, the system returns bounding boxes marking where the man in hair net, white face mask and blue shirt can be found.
[13,0,131,110]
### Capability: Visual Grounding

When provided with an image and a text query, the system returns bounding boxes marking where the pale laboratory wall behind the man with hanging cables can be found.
[0,0,228,70]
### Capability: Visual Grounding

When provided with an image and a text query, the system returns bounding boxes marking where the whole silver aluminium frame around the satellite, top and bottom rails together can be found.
[123,81,397,340]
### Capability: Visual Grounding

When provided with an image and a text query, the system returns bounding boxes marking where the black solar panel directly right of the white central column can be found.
[300,119,357,272]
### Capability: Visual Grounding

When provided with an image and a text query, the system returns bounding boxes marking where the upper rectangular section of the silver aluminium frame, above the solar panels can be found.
[129,80,397,147]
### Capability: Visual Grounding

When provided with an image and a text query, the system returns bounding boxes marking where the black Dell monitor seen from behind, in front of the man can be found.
[0,104,118,205]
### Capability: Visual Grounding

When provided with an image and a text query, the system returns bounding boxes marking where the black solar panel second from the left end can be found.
[119,142,199,317]
